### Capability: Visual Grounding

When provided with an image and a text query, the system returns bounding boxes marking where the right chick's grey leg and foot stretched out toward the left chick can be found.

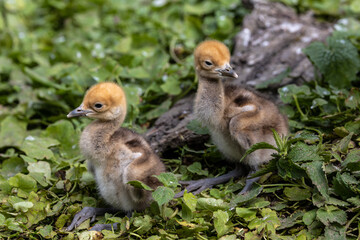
[175,164,243,198]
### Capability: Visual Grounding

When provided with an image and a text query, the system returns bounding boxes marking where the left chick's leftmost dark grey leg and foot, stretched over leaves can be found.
[66,207,119,231]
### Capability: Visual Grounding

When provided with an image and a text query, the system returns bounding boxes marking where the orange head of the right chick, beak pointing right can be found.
[194,40,238,79]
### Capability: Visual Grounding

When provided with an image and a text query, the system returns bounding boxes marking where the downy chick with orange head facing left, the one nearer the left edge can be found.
[67,82,165,231]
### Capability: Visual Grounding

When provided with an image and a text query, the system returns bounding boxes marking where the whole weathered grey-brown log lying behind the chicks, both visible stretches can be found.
[145,0,332,154]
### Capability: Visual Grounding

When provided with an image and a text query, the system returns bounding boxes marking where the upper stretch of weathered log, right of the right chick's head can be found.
[232,0,332,87]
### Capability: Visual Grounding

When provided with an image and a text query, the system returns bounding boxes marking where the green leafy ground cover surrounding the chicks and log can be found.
[0,0,360,240]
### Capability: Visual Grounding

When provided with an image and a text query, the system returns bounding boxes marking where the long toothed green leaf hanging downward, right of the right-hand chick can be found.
[305,161,329,200]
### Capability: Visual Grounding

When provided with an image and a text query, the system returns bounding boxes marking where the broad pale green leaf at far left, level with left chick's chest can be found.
[21,135,59,159]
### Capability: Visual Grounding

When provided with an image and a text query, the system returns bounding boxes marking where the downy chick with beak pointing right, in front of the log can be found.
[176,40,288,197]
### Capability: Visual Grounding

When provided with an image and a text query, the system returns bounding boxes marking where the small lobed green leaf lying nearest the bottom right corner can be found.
[316,206,346,226]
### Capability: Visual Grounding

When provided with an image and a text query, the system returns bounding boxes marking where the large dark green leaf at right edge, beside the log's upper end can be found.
[304,37,360,88]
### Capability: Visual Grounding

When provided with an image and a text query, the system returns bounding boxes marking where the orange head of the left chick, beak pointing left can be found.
[67,82,126,122]
